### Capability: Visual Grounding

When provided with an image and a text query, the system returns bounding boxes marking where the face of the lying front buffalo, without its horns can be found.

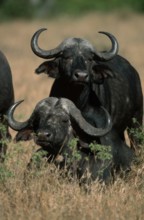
[33,108,71,154]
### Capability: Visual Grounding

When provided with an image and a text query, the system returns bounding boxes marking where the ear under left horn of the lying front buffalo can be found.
[14,129,33,142]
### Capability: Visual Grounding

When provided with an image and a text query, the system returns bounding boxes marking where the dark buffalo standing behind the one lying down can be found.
[31,28,143,148]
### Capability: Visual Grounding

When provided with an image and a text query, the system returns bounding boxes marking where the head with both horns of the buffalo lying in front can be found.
[8,97,112,156]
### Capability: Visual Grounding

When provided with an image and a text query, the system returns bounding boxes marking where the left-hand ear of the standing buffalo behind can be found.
[35,60,59,78]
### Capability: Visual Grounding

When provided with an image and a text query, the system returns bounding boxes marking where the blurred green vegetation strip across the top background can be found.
[0,0,144,20]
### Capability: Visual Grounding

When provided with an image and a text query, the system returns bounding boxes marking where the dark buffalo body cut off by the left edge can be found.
[0,51,14,161]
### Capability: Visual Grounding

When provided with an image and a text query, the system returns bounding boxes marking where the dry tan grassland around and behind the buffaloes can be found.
[0,13,144,220]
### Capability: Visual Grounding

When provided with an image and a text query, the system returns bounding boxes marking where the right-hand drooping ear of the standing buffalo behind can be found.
[93,65,115,84]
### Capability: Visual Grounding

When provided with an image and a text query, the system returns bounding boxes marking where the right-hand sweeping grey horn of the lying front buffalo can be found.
[61,98,112,137]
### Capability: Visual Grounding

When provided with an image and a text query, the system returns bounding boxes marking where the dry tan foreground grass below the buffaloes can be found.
[0,137,144,220]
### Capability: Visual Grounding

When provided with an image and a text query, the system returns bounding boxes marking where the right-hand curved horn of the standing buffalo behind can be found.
[95,31,119,61]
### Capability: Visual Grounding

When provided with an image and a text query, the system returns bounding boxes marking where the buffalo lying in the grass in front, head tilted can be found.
[8,97,133,183]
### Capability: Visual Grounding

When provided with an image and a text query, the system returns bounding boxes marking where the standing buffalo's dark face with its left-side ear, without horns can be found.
[36,39,94,84]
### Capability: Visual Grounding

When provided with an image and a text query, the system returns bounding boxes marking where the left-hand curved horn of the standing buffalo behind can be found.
[31,28,63,59]
